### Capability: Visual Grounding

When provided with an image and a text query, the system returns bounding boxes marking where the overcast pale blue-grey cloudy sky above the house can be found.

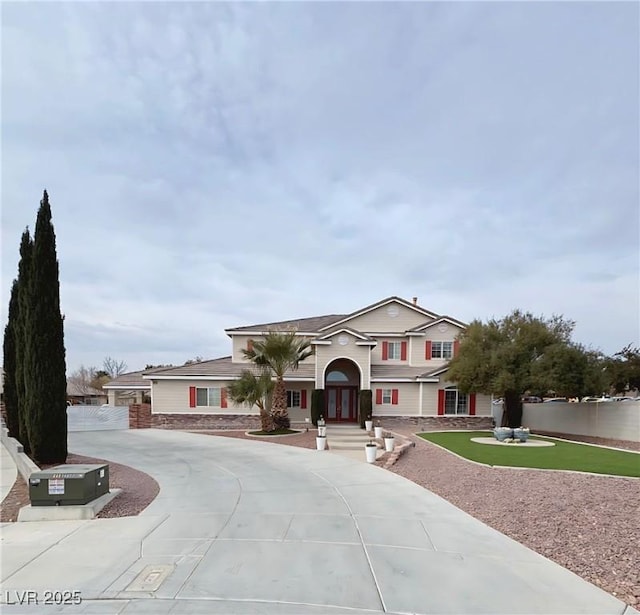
[1,2,640,371]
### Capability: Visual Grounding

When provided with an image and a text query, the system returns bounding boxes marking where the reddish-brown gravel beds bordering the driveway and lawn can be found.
[0,430,640,608]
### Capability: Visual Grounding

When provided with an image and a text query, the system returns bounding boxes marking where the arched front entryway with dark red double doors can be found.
[324,359,360,423]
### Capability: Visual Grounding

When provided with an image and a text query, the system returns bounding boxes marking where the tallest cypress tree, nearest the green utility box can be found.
[26,190,67,463]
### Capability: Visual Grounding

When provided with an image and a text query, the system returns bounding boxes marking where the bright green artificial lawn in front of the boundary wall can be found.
[418,431,640,477]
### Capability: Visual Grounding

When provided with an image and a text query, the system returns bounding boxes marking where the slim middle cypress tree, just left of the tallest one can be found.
[14,229,33,454]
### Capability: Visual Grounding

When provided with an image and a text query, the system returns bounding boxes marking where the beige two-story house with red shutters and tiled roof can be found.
[117,297,491,426]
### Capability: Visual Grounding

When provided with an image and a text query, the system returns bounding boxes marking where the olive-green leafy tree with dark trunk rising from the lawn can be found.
[447,310,574,427]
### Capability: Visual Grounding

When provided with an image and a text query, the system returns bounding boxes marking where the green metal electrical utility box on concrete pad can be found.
[29,464,109,506]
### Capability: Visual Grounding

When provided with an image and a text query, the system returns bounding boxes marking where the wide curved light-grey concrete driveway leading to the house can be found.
[2,430,632,615]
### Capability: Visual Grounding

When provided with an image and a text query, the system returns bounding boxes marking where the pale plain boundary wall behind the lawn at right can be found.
[522,401,640,442]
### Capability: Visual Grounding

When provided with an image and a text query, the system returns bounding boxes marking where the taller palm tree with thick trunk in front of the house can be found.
[242,330,313,429]
